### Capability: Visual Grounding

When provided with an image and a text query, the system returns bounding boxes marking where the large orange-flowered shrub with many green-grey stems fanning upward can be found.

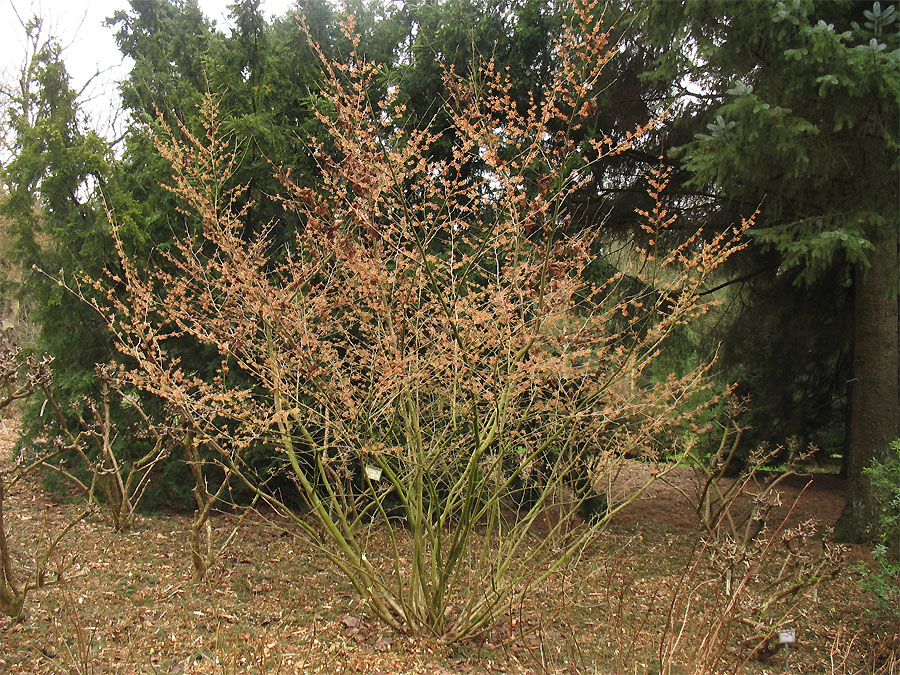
[82,2,747,641]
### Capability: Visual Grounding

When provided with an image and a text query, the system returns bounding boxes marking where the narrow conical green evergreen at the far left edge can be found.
[0,19,114,397]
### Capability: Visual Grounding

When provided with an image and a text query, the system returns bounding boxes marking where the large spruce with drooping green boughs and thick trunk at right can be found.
[645,0,900,537]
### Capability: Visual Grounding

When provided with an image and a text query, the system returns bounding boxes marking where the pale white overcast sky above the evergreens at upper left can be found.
[0,0,294,133]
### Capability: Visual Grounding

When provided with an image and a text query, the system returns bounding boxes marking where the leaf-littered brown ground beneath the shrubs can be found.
[0,420,900,675]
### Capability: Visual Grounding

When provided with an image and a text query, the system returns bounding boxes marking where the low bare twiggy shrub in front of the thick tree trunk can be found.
[659,405,846,673]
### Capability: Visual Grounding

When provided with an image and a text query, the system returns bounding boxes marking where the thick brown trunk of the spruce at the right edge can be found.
[835,231,900,542]
